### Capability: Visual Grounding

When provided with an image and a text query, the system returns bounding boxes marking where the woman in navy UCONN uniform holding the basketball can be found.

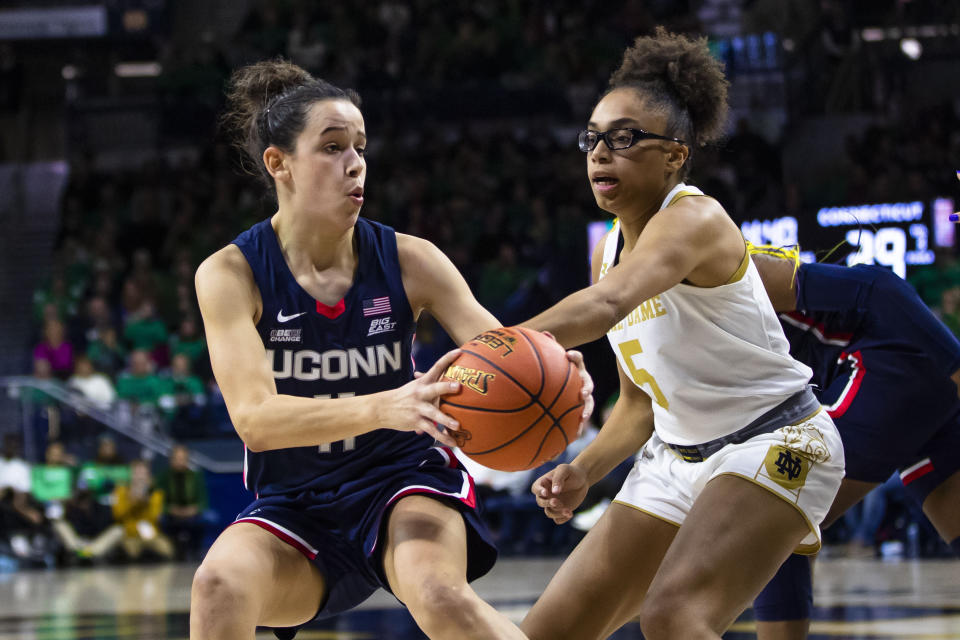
[190,61,592,640]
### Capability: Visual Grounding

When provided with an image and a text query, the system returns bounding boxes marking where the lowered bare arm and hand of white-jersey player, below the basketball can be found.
[530,363,653,524]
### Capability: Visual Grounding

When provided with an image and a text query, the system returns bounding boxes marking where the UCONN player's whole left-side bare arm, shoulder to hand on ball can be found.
[196,245,458,451]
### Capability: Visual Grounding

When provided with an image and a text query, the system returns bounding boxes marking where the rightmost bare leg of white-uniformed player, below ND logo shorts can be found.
[640,475,809,640]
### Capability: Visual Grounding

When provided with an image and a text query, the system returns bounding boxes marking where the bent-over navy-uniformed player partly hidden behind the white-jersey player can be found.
[750,246,960,640]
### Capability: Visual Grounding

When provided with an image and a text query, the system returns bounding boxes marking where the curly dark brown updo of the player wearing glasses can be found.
[607,27,730,171]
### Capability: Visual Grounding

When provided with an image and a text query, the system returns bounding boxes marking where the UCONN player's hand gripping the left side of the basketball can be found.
[380,349,460,447]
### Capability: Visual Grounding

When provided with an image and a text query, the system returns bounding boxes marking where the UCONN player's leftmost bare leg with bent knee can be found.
[190,523,325,640]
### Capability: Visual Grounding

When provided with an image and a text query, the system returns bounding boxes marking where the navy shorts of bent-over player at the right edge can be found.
[820,342,960,503]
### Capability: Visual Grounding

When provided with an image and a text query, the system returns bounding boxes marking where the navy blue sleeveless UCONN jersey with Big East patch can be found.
[233,218,433,497]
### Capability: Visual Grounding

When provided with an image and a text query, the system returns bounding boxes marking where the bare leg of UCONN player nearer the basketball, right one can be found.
[383,495,526,640]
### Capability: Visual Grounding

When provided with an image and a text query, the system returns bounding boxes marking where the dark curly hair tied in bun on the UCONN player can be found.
[221,59,360,188]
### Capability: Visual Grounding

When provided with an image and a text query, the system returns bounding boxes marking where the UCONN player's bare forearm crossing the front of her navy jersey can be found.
[231,391,390,451]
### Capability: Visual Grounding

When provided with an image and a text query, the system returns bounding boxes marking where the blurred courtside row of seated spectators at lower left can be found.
[0,435,216,570]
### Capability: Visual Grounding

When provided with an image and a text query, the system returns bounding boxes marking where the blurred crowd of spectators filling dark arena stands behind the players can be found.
[0,0,960,561]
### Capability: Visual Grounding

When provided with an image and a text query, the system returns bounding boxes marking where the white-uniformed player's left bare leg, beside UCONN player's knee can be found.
[520,502,679,640]
